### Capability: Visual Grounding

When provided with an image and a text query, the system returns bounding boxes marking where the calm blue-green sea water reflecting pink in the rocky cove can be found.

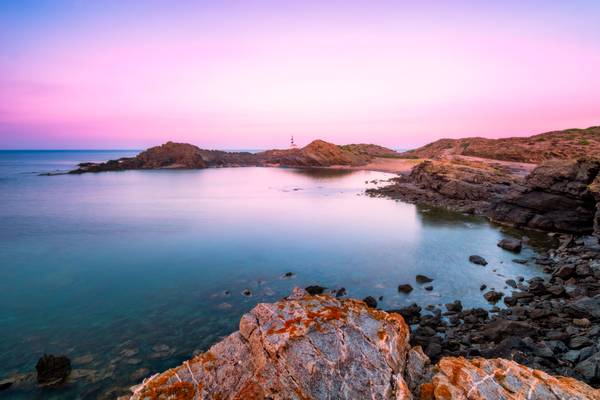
[0,151,543,399]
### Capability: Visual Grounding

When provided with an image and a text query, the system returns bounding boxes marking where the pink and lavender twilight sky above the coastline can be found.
[0,0,600,149]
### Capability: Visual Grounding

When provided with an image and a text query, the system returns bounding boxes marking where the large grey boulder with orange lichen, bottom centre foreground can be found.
[132,290,410,400]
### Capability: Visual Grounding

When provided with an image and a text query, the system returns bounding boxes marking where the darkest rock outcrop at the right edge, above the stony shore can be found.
[488,160,600,234]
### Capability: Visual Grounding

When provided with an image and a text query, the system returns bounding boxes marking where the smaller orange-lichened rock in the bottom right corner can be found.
[420,357,600,400]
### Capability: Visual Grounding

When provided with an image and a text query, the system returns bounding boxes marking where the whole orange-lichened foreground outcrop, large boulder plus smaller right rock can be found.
[131,289,600,400]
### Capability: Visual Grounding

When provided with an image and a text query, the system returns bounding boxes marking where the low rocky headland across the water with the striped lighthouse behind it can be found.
[70,140,398,174]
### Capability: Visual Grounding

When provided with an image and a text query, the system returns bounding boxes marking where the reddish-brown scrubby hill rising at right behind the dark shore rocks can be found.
[401,126,600,163]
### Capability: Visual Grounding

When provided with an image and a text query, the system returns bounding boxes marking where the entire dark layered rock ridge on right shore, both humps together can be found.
[367,159,600,234]
